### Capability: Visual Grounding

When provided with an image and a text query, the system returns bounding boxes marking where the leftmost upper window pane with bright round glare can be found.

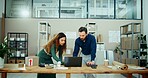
[6,0,32,17]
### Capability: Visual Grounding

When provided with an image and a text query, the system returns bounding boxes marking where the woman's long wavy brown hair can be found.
[44,32,66,53]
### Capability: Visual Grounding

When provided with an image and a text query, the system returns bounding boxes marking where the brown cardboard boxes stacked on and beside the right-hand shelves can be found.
[114,23,141,65]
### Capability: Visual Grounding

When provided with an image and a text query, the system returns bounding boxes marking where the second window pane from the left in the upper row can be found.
[33,0,59,18]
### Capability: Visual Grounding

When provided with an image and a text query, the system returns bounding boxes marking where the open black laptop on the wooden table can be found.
[64,57,82,67]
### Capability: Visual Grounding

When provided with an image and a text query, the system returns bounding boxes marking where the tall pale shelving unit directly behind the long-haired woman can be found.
[38,21,51,52]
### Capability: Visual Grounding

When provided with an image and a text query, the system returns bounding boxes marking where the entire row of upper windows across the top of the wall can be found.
[5,0,142,19]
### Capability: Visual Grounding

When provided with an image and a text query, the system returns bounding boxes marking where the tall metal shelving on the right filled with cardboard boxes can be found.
[119,23,147,66]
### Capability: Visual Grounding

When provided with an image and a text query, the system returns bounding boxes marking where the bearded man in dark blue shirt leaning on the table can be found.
[73,27,96,78]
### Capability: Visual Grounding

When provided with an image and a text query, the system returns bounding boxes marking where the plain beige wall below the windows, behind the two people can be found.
[5,18,143,54]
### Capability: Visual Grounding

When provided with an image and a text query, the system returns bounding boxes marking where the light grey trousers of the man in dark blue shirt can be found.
[80,53,95,78]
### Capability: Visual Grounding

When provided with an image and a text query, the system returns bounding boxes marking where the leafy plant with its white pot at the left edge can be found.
[0,36,11,68]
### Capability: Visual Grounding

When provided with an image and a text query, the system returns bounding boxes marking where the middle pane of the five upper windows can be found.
[60,0,87,18]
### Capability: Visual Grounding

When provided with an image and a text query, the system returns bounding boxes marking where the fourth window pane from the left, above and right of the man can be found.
[88,0,114,18]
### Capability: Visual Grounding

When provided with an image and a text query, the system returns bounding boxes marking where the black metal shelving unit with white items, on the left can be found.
[7,32,28,64]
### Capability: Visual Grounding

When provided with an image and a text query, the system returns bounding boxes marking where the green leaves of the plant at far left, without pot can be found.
[0,36,11,58]
